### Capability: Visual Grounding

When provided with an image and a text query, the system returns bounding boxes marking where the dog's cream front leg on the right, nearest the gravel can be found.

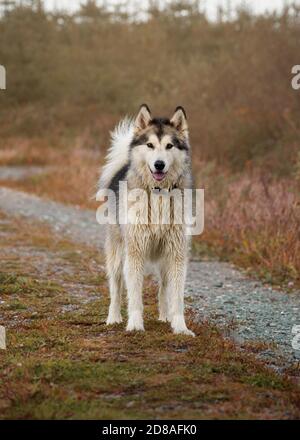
[168,258,195,336]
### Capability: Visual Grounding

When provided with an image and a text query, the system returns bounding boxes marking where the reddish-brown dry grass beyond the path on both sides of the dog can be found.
[2,148,300,288]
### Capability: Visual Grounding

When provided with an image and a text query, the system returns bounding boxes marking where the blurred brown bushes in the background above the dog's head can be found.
[0,1,300,176]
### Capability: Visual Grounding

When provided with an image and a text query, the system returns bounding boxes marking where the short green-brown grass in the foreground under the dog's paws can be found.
[0,211,300,419]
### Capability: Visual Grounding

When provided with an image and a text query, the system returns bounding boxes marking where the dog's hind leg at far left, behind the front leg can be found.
[106,229,125,325]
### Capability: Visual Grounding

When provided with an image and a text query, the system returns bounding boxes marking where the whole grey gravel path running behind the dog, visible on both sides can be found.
[0,184,300,371]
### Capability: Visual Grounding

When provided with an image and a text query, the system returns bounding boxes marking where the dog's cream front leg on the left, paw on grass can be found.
[124,245,144,331]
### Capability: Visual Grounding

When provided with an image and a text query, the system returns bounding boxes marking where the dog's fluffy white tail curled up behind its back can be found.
[98,116,134,190]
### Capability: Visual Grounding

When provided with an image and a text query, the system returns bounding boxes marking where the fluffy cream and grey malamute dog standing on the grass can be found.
[99,104,194,336]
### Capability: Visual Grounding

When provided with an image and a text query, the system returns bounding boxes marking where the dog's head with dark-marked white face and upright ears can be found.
[131,104,189,187]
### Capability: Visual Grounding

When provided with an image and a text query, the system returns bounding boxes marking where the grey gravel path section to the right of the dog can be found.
[186,262,300,371]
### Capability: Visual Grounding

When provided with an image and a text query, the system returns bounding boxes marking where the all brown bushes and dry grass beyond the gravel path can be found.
[0,2,300,292]
